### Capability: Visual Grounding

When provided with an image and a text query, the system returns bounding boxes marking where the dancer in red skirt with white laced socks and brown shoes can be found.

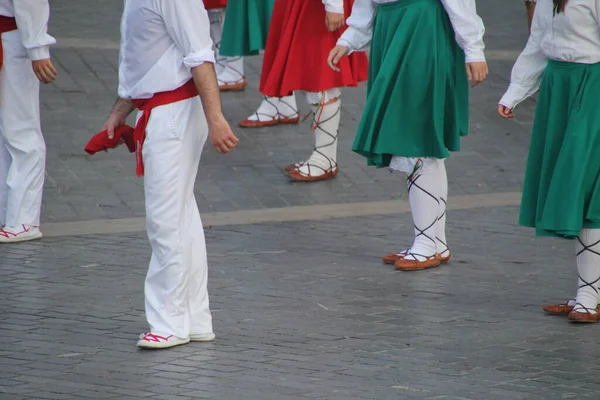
[240,0,367,182]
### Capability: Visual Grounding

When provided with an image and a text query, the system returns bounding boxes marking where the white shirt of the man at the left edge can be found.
[0,0,56,61]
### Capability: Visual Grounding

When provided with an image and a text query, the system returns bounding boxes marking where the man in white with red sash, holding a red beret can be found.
[104,0,238,348]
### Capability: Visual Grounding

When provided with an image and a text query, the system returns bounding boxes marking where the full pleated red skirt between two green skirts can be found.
[260,0,368,97]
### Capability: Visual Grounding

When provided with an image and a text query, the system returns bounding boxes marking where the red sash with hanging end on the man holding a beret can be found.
[131,79,198,176]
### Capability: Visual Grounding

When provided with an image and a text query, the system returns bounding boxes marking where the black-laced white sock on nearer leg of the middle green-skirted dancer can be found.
[406,162,442,261]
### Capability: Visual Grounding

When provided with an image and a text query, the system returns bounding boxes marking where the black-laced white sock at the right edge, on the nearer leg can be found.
[574,228,600,313]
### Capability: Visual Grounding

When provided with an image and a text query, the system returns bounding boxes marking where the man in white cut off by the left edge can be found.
[0,0,57,243]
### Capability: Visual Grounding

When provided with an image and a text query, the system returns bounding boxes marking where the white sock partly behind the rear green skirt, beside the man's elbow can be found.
[208,8,244,85]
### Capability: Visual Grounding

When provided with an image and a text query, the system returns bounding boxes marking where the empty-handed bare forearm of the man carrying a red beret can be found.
[192,63,239,153]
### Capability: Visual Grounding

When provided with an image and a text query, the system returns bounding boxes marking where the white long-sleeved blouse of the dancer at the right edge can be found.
[500,0,600,109]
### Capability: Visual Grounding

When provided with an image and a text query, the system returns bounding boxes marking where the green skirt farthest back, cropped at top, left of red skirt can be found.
[220,0,275,57]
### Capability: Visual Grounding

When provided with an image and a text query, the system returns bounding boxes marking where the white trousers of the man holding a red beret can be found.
[138,97,212,338]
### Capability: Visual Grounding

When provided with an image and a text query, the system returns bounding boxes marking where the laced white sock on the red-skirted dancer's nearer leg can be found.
[297,97,342,176]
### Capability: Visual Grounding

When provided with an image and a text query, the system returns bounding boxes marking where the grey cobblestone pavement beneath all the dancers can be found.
[0,0,600,400]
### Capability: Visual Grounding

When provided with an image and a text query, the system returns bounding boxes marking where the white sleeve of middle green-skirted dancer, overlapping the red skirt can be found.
[337,0,376,52]
